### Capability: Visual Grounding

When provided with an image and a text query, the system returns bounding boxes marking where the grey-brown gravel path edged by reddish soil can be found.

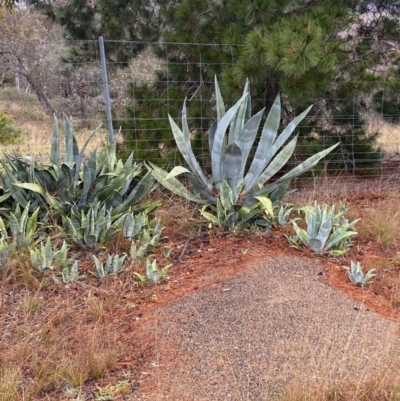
[134,256,400,401]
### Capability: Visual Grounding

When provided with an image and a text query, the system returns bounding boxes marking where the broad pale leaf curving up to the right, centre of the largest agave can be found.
[211,93,247,190]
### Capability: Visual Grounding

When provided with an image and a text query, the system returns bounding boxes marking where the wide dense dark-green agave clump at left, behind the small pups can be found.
[0,112,154,216]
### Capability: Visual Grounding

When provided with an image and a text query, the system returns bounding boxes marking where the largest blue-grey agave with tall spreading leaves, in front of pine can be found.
[151,79,337,228]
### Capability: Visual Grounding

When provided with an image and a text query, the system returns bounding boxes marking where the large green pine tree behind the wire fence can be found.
[36,0,400,171]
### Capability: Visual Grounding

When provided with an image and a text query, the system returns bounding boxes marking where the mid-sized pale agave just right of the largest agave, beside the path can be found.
[287,202,359,256]
